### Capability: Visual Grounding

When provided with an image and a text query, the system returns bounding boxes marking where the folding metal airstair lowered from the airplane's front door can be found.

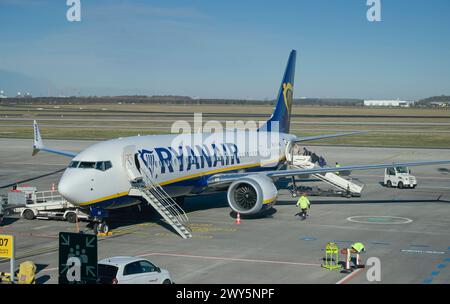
[127,147,192,239]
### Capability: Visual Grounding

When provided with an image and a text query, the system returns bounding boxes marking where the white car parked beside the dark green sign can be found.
[98,256,173,284]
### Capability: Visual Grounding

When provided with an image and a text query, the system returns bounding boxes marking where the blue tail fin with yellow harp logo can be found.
[260,50,297,133]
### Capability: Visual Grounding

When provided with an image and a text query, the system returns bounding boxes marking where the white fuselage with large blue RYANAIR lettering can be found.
[58,131,295,209]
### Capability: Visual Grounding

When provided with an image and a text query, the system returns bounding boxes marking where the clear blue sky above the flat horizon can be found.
[0,0,450,99]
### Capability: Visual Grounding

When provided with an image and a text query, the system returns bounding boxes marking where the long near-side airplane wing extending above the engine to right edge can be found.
[208,160,450,186]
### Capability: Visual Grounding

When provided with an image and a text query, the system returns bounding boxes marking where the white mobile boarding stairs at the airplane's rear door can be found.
[290,155,364,196]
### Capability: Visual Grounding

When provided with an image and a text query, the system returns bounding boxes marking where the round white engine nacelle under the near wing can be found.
[227,174,278,215]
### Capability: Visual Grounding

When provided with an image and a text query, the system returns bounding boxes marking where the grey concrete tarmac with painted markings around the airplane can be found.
[0,139,450,284]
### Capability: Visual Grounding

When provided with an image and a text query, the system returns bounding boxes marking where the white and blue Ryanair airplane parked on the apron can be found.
[33,50,450,234]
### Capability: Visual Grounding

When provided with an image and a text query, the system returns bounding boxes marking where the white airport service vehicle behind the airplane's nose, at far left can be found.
[12,187,89,223]
